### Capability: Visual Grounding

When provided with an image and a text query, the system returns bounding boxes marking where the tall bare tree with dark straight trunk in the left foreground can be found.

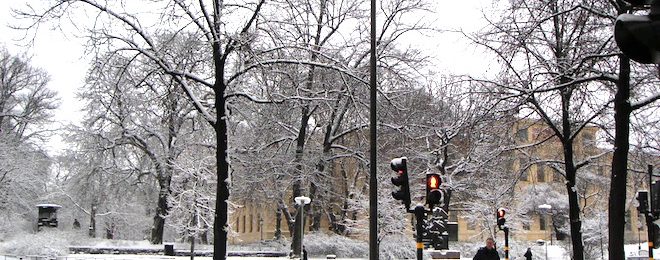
[18,0,265,259]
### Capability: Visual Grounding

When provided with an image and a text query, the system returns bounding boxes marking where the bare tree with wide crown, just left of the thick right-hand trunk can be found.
[476,0,617,259]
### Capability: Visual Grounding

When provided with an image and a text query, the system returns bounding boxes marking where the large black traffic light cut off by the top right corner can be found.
[614,0,660,64]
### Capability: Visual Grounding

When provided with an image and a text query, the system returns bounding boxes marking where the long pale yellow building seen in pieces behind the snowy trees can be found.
[229,119,658,244]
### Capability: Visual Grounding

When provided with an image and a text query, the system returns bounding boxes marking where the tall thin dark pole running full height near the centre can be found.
[369,0,378,260]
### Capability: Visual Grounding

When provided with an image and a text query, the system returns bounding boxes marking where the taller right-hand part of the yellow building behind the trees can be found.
[450,120,658,243]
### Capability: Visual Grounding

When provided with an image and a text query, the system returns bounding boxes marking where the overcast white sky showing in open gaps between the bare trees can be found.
[0,0,494,155]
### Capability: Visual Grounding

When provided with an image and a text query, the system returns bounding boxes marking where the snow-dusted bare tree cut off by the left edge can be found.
[0,47,58,229]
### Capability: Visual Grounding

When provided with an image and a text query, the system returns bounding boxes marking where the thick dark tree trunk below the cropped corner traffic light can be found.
[608,55,632,259]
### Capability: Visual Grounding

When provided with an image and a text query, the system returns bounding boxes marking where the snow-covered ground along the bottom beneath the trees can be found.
[0,232,660,260]
